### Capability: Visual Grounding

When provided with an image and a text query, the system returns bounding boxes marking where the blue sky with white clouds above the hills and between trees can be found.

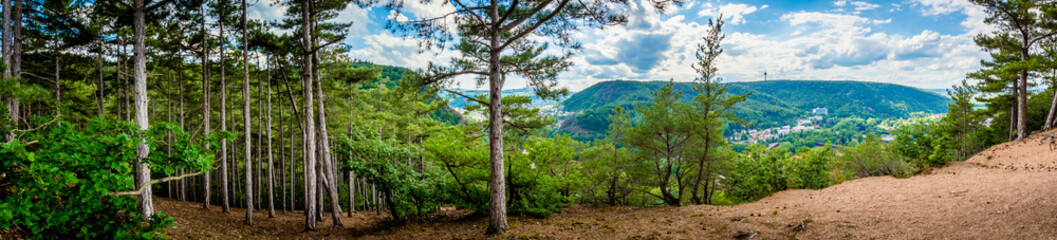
[249,0,990,91]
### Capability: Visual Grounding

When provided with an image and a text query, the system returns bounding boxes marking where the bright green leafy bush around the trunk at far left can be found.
[0,117,212,239]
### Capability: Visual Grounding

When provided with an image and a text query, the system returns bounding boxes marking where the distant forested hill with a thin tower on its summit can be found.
[561,80,948,137]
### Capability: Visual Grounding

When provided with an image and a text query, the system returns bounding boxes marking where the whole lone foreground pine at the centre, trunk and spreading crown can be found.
[389,0,676,234]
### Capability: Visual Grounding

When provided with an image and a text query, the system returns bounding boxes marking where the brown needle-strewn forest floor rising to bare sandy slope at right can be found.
[155,130,1057,239]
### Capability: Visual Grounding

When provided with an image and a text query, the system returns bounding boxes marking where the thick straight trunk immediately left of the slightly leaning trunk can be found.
[301,0,317,230]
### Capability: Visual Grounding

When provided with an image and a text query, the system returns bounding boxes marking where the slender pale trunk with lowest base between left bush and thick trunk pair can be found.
[242,0,254,225]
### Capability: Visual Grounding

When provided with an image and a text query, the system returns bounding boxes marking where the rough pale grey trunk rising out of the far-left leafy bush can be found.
[132,0,154,220]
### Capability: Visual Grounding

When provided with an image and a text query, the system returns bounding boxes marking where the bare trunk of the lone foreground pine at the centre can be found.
[485,0,509,234]
